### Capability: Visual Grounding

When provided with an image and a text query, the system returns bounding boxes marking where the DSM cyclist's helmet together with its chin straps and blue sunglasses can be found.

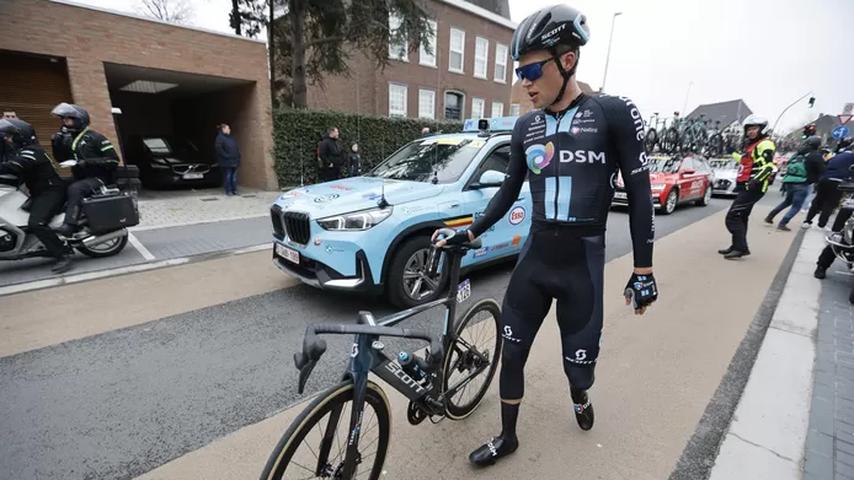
[510,5,590,106]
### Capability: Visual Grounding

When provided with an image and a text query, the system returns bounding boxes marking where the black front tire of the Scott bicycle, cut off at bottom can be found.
[261,381,391,480]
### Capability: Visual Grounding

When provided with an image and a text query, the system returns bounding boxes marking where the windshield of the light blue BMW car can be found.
[368,137,485,183]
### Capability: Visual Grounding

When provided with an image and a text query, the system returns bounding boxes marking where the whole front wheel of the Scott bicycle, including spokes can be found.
[261,382,391,480]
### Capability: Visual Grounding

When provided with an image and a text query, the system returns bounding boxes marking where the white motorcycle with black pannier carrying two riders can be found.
[0,167,139,260]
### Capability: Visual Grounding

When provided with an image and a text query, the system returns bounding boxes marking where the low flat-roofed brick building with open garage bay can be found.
[0,0,276,189]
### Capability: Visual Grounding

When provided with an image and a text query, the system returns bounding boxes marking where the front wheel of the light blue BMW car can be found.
[386,235,447,308]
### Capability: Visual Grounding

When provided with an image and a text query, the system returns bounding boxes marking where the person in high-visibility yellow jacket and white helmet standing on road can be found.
[718,115,777,260]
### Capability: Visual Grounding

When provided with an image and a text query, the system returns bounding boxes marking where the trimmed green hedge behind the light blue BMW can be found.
[273,108,463,188]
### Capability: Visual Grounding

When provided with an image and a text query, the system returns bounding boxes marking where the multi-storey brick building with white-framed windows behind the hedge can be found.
[290,0,516,120]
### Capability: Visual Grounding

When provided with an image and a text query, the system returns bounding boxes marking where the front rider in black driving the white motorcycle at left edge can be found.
[0,119,71,274]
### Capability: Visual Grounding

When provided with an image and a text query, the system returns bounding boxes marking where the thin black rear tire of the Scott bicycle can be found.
[442,298,502,420]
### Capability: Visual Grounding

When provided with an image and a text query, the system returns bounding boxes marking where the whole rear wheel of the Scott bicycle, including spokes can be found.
[442,299,501,420]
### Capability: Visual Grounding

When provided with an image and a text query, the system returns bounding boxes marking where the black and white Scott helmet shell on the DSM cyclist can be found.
[510,5,590,61]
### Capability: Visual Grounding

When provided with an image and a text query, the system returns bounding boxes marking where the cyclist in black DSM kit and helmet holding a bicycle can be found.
[437,5,658,466]
